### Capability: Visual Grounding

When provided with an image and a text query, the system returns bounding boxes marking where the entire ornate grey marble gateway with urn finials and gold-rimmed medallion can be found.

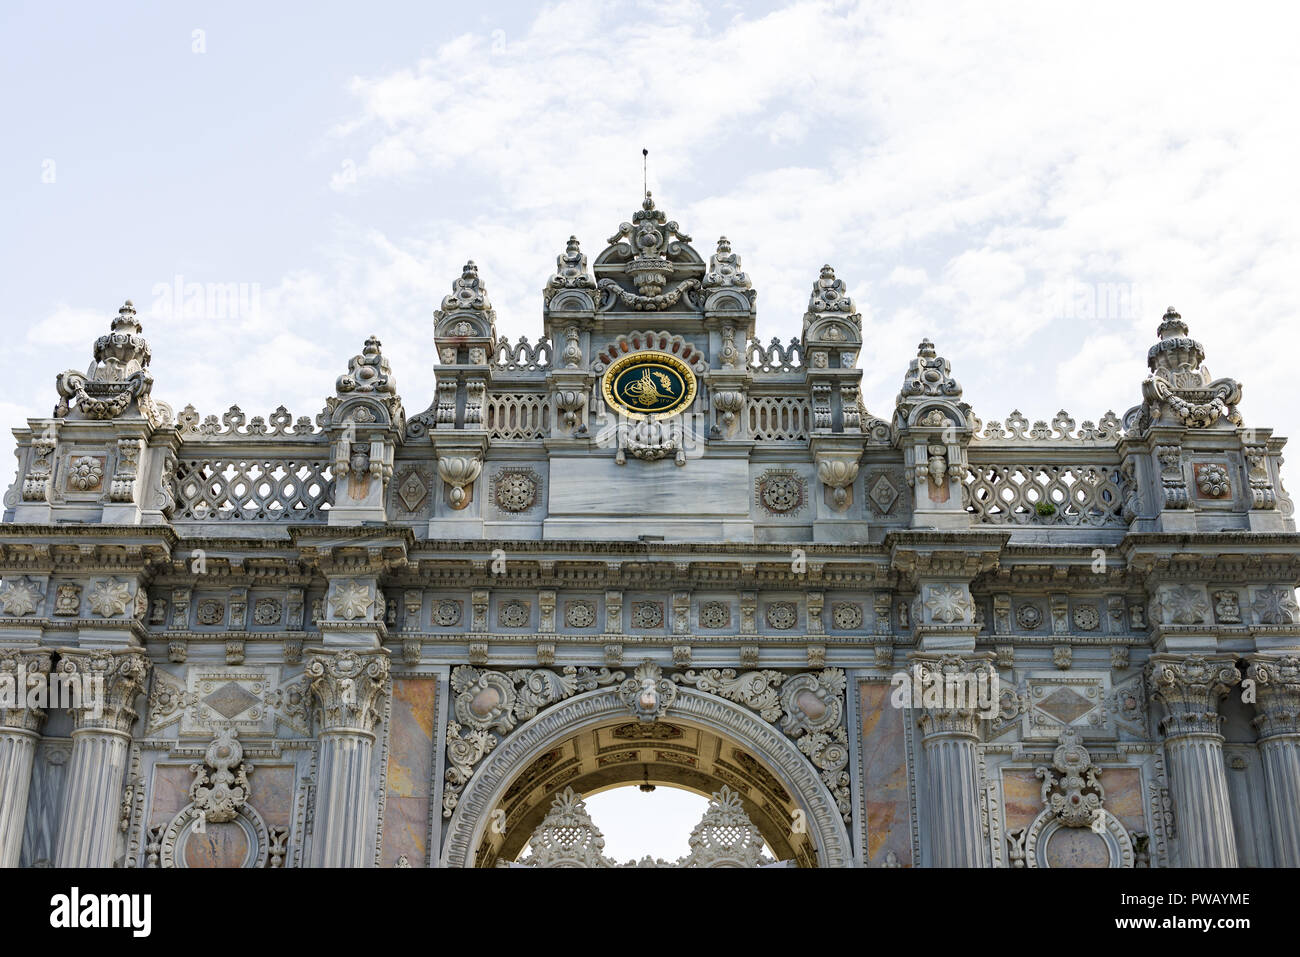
[0,194,1300,867]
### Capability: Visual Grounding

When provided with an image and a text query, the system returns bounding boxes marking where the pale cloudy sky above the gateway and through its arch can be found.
[0,0,1300,857]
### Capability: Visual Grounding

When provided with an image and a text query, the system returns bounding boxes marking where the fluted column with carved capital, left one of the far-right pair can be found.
[1147,655,1242,867]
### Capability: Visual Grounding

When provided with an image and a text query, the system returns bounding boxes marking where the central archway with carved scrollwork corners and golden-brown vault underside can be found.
[443,662,852,866]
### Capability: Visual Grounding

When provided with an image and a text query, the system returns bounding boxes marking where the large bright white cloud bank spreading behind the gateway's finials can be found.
[12,0,1300,486]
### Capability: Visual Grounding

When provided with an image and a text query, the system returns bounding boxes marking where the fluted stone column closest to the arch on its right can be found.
[911,655,996,867]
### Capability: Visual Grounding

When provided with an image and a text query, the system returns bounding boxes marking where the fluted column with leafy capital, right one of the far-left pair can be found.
[55,649,150,867]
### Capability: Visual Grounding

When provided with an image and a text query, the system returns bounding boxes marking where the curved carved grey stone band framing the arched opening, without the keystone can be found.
[442,685,853,867]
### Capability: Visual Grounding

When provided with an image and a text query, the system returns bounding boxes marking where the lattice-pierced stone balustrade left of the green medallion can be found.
[172,449,334,524]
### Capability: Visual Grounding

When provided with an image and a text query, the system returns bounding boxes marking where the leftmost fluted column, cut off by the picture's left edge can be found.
[0,649,49,867]
